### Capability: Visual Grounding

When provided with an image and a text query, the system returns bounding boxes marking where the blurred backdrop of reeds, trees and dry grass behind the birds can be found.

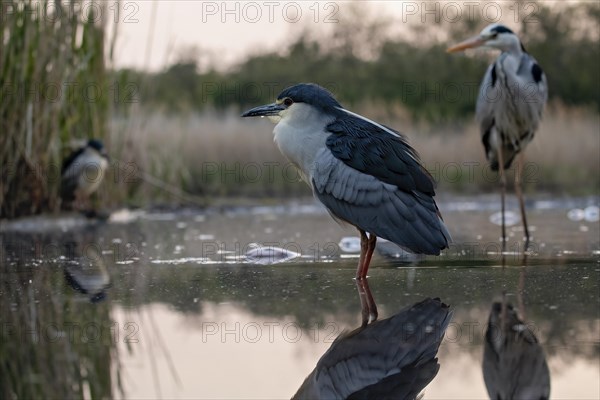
[0,0,600,216]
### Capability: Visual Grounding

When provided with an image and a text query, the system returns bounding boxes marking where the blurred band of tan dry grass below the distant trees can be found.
[111,101,600,204]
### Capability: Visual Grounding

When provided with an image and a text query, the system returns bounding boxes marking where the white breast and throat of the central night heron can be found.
[273,103,333,185]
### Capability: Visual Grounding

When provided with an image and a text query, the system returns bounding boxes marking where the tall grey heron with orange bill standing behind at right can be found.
[448,24,548,247]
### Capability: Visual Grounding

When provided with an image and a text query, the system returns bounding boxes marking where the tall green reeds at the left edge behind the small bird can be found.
[0,0,110,218]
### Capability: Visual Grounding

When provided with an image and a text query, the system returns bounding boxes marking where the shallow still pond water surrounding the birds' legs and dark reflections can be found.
[0,199,600,399]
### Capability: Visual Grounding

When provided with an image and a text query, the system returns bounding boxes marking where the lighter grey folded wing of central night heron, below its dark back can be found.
[311,148,450,255]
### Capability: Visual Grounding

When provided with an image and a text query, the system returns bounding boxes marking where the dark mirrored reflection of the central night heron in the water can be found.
[293,296,451,399]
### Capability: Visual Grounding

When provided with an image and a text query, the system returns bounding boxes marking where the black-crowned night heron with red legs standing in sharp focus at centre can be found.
[242,83,450,279]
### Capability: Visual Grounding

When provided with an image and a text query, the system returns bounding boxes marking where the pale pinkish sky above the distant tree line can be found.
[103,0,538,71]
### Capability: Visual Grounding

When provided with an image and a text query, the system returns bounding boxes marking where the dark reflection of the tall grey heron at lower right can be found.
[483,300,550,400]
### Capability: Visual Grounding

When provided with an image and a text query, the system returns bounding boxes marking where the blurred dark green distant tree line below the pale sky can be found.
[115,2,600,122]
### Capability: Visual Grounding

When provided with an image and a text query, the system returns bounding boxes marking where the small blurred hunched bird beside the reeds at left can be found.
[61,139,108,209]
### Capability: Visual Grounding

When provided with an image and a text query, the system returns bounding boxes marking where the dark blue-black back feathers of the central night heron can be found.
[326,115,435,196]
